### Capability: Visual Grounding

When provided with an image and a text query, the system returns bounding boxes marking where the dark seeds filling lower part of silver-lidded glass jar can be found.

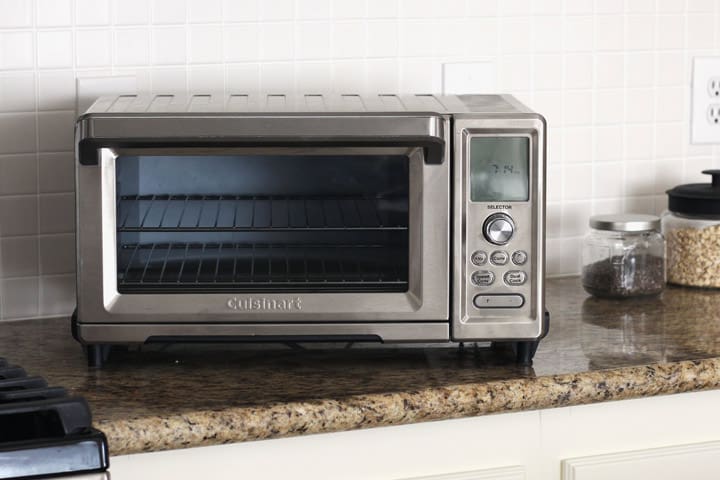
[582,255,665,298]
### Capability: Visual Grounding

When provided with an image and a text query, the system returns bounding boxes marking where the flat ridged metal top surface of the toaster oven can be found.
[81,93,532,114]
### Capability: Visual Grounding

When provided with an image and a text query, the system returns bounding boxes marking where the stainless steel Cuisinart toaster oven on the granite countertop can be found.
[72,95,548,364]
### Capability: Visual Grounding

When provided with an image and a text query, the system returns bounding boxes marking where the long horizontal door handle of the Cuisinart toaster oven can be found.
[75,113,446,165]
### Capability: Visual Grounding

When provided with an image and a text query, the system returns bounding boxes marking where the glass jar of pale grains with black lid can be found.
[662,170,720,288]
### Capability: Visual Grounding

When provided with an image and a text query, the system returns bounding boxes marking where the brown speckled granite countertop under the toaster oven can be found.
[0,278,720,455]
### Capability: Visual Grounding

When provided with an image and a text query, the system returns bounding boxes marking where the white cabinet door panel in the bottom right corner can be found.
[562,442,720,480]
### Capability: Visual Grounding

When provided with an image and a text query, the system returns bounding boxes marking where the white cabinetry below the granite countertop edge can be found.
[111,390,720,480]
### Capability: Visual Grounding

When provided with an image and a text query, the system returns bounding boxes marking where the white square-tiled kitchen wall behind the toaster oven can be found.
[0,0,720,319]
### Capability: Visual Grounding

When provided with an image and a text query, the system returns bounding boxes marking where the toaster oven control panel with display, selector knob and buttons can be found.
[453,121,543,339]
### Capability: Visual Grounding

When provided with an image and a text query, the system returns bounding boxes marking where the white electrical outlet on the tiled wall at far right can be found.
[690,57,720,143]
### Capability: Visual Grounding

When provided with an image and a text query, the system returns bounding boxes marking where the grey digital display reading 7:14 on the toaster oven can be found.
[470,137,530,202]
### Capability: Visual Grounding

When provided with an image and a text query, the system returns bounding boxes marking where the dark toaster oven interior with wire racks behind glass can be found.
[115,150,410,294]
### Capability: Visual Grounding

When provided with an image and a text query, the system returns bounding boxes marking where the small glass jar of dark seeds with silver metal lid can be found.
[582,214,665,298]
